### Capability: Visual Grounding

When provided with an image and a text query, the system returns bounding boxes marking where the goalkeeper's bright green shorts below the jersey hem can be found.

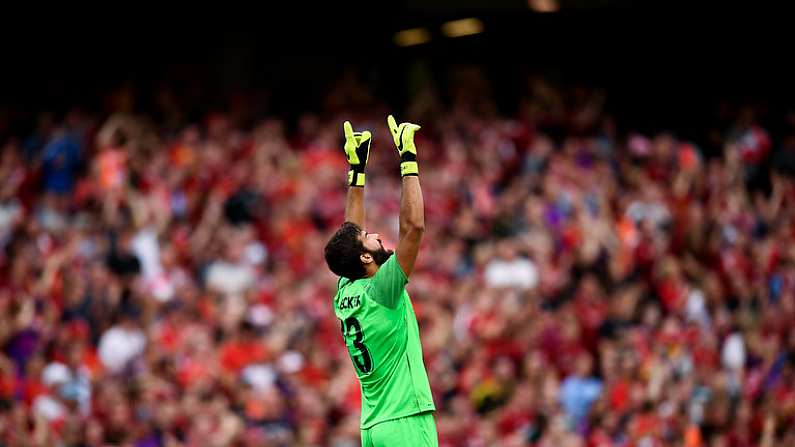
[362,411,439,447]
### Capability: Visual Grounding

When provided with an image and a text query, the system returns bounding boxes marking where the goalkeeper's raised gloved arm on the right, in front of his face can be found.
[387,115,425,277]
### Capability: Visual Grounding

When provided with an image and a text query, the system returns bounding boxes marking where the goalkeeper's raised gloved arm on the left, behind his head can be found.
[342,121,372,228]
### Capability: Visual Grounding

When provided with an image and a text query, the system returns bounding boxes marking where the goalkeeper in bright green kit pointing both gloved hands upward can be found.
[324,115,438,447]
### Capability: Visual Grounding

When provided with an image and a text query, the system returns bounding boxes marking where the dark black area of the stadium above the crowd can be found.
[0,0,795,144]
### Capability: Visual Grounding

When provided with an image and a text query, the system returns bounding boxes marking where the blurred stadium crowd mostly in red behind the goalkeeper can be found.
[0,70,795,447]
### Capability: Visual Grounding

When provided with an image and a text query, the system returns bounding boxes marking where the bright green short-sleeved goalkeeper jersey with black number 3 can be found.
[334,255,436,429]
